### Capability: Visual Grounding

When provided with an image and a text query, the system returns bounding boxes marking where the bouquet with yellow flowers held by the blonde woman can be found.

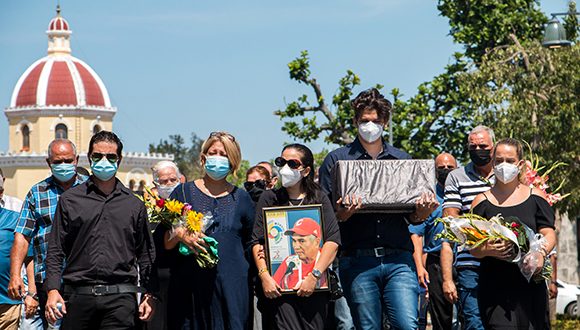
[137,188,219,268]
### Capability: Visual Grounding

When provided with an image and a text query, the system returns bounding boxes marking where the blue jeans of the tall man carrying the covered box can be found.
[339,252,419,330]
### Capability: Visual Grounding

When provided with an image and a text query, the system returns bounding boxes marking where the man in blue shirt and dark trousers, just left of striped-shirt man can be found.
[409,153,457,330]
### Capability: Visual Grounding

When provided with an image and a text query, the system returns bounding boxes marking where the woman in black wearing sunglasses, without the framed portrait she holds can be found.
[252,144,340,330]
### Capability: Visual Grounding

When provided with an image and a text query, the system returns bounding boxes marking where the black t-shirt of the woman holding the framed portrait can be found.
[251,188,340,246]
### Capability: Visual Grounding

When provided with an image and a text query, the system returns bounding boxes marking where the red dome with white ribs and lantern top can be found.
[10,8,111,110]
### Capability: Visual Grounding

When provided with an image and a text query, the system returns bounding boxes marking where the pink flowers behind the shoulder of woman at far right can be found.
[523,143,570,205]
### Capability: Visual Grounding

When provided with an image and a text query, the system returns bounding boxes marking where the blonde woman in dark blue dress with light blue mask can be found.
[163,132,254,329]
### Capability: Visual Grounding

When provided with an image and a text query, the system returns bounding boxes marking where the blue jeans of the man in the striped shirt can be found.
[457,268,484,330]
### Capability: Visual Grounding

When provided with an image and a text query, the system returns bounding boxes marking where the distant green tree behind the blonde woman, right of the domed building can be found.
[149,133,203,180]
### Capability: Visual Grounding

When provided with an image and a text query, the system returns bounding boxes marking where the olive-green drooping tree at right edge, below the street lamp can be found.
[459,35,580,214]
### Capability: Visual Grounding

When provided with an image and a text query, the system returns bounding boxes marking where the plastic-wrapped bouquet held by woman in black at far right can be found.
[435,213,552,282]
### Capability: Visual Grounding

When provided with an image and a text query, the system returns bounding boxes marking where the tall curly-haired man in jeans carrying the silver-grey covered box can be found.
[319,88,438,329]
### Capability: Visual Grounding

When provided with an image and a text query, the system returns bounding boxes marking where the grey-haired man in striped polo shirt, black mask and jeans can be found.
[441,126,495,330]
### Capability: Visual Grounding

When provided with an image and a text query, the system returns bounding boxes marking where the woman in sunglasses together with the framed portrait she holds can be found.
[252,144,340,329]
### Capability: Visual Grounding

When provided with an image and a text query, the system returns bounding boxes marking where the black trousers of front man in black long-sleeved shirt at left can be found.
[61,293,140,330]
